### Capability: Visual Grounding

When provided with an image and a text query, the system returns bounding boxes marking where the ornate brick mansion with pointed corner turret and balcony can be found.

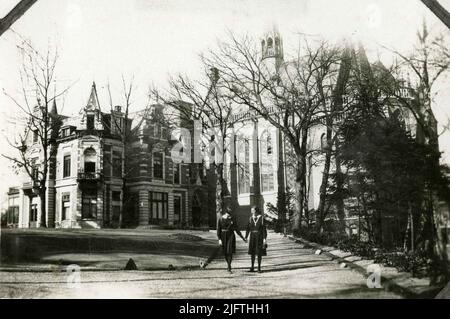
[7,83,209,228]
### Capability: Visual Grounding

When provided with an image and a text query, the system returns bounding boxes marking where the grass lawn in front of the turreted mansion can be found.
[1,229,217,270]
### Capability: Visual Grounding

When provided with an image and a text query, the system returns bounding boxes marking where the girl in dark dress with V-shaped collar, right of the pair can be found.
[245,206,267,272]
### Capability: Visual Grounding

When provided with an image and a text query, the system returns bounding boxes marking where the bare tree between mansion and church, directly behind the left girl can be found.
[152,65,241,217]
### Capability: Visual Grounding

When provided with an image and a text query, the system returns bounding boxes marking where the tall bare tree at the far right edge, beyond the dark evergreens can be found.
[388,23,450,280]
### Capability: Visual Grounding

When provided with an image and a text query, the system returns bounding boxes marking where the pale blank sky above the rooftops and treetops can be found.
[0,0,450,204]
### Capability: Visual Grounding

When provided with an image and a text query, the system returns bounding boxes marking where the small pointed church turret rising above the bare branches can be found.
[261,26,284,73]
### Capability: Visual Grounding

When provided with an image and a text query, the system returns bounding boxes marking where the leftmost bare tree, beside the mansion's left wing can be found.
[3,40,69,227]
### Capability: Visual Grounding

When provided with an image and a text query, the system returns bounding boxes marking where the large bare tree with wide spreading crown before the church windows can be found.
[202,34,340,229]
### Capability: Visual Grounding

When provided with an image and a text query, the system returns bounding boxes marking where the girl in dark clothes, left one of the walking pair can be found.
[217,208,247,273]
